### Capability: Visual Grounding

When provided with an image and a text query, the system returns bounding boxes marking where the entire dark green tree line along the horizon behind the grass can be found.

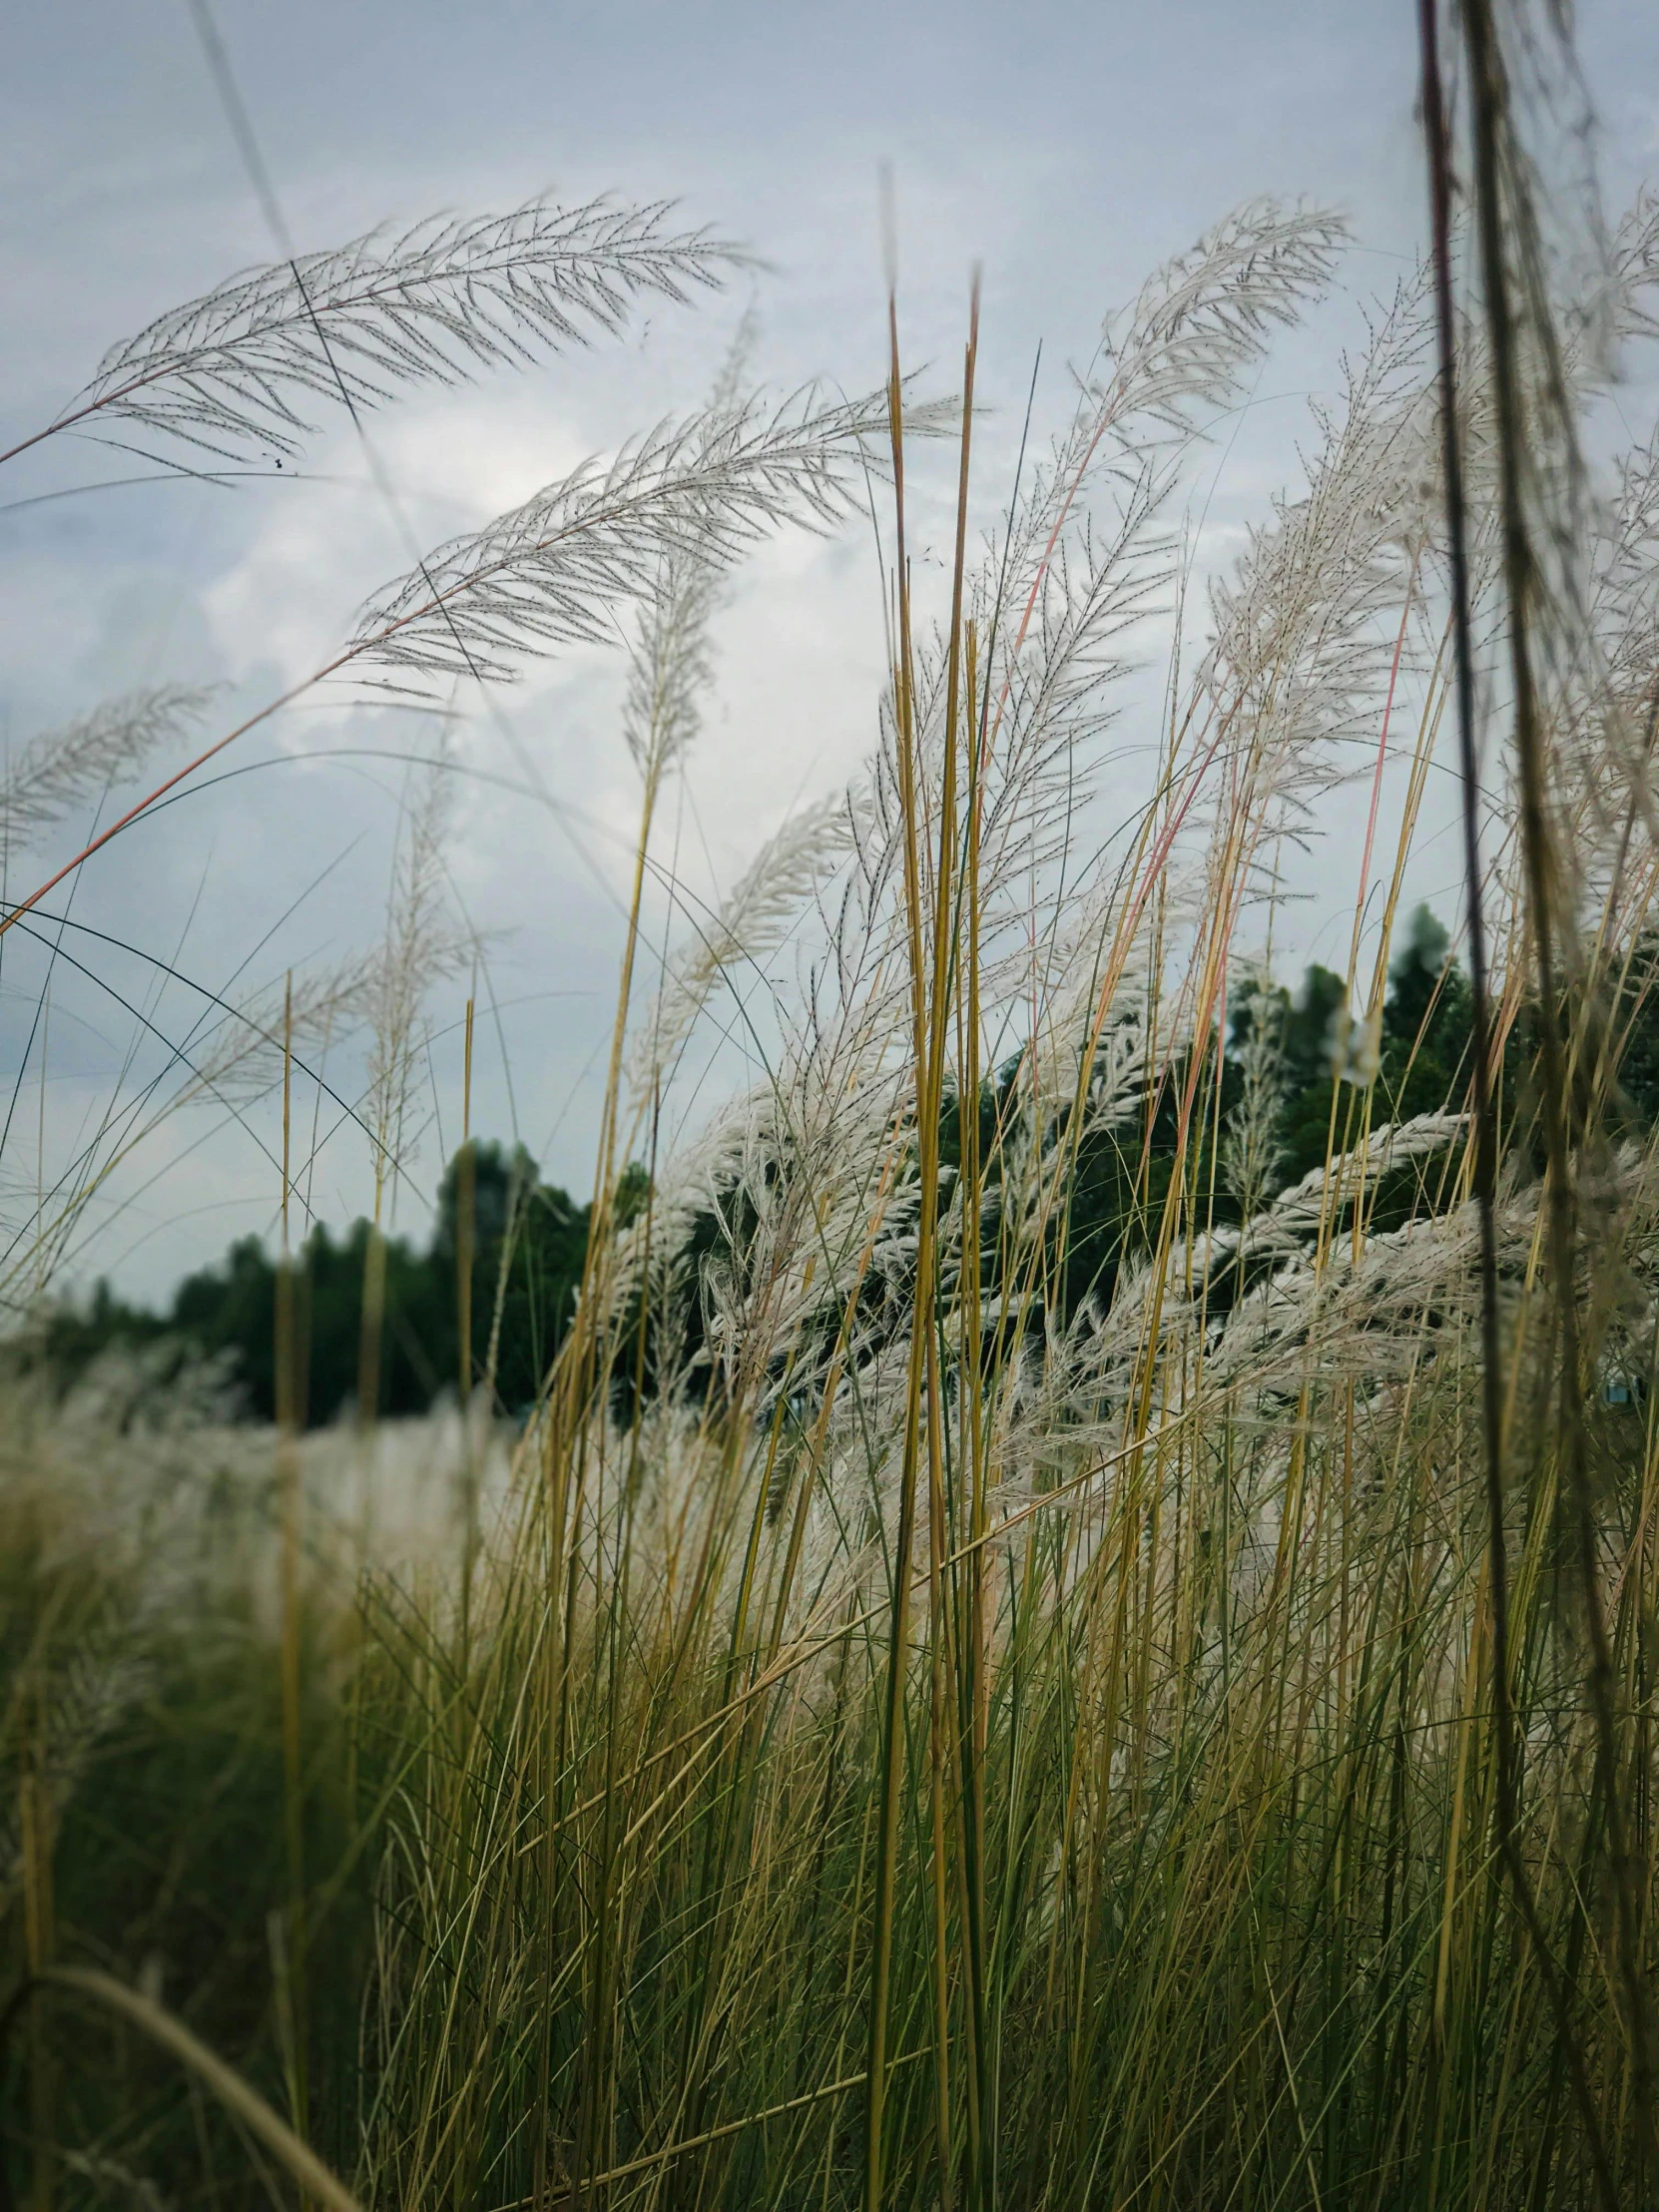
[42,907,1659,1424]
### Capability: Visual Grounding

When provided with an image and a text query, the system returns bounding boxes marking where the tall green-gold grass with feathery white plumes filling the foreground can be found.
[0,0,1659,2212]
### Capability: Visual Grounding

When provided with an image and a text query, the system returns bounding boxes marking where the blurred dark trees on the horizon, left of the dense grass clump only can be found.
[47,1144,588,1422]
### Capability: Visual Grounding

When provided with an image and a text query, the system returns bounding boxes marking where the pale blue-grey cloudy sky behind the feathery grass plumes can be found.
[0,0,1659,1297]
